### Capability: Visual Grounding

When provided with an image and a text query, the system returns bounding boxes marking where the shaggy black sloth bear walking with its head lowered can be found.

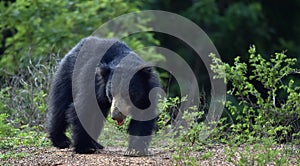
[47,37,159,156]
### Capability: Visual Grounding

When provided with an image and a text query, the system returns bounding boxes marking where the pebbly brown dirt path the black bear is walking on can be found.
[0,147,232,166]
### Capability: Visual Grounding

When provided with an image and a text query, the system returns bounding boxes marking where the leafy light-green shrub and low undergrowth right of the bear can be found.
[159,46,300,165]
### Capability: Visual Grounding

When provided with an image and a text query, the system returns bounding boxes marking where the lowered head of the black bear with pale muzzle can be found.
[98,66,159,125]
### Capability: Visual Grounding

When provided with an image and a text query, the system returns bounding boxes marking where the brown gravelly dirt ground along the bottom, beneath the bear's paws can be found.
[0,145,300,166]
